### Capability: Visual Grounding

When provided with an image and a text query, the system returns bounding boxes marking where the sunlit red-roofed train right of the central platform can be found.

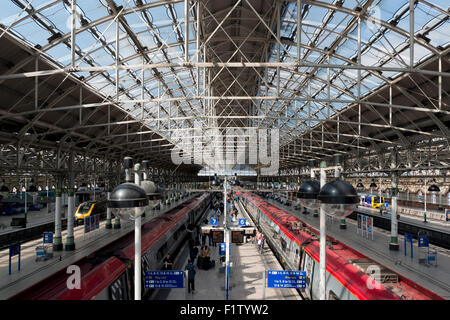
[241,193,443,300]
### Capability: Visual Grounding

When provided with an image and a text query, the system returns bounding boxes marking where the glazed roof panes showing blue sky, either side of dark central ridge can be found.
[0,0,450,149]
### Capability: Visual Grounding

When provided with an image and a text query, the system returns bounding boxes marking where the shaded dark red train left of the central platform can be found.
[10,193,212,300]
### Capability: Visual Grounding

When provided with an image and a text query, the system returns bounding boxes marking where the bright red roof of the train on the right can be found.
[244,193,442,300]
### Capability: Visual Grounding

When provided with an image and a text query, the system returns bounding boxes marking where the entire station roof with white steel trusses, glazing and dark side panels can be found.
[0,0,450,176]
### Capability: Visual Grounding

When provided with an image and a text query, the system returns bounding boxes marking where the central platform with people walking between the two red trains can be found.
[155,202,301,300]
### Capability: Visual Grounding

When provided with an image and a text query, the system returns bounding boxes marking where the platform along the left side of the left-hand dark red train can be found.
[0,195,194,300]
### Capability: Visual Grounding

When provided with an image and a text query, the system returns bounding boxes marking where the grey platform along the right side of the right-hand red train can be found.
[266,199,450,299]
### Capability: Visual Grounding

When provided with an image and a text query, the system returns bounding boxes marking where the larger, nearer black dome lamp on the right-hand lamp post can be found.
[317,179,359,218]
